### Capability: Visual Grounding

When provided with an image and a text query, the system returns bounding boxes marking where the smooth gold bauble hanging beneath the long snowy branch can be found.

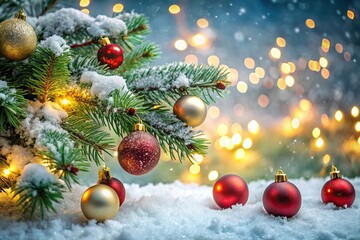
[173,95,206,127]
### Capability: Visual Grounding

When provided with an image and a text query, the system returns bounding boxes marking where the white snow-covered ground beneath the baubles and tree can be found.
[0,177,360,240]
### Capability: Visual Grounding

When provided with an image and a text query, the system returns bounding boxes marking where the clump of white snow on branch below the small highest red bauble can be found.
[80,71,128,100]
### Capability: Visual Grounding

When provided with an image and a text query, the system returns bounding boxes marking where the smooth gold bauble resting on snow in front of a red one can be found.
[81,184,120,222]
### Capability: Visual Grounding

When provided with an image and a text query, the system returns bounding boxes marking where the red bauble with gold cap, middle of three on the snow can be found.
[263,170,301,217]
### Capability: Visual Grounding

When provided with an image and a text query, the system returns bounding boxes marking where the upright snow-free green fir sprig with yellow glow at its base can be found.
[26,47,70,102]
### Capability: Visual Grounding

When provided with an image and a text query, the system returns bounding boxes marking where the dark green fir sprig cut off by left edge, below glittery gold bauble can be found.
[0,83,26,133]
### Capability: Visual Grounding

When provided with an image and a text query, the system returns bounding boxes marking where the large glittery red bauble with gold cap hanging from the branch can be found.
[118,123,160,175]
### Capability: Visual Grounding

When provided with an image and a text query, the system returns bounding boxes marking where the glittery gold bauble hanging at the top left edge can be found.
[0,18,37,61]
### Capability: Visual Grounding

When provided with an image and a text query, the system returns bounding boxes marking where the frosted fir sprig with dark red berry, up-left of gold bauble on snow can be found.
[41,130,89,189]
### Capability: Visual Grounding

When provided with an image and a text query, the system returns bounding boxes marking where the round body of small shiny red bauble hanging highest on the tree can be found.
[98,44,124,69]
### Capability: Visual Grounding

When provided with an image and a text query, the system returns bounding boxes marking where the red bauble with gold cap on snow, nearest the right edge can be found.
[321,166,355,207]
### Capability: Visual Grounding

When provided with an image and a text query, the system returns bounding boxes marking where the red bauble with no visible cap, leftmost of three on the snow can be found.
[213,174,249,208]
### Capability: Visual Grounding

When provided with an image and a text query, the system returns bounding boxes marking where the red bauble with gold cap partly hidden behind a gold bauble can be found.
[98,167,126,206]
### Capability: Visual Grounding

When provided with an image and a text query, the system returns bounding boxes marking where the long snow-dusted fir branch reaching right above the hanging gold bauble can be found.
[123,63,230,104]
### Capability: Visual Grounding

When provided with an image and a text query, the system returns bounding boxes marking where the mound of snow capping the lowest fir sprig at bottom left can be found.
[18,163,57,186]
